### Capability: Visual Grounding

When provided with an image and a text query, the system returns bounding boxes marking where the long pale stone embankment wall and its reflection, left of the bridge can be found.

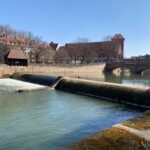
[0,64,105,80]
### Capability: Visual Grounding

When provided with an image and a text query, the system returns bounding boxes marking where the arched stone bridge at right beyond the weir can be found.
[104,59,150,74]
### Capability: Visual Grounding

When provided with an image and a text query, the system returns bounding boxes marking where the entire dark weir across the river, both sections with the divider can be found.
[10,74,150,109]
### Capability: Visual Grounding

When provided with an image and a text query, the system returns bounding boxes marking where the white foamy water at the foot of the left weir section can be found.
[0,78,46,92]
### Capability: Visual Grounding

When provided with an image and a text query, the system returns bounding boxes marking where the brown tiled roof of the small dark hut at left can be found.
[7,49,28,59]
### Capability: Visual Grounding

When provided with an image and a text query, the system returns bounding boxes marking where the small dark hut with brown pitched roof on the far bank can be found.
[5,49,28,66]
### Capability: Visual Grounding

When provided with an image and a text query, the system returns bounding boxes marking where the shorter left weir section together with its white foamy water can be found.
[0,74,61,92]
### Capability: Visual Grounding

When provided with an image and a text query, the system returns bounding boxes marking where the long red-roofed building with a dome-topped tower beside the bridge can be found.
[58,34,125,62]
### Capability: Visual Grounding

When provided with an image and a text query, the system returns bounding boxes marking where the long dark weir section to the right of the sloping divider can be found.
[56,78,150,109]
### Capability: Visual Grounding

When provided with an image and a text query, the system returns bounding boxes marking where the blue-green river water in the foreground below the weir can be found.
[0,79,141,150]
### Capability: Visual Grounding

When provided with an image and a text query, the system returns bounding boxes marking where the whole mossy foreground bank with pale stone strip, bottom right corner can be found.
[62,111,150,150]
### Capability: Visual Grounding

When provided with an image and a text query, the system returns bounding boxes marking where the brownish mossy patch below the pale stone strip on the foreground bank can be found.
[63,127,150,150]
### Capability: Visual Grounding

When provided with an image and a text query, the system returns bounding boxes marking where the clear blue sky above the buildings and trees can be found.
[0,0,150,57]
